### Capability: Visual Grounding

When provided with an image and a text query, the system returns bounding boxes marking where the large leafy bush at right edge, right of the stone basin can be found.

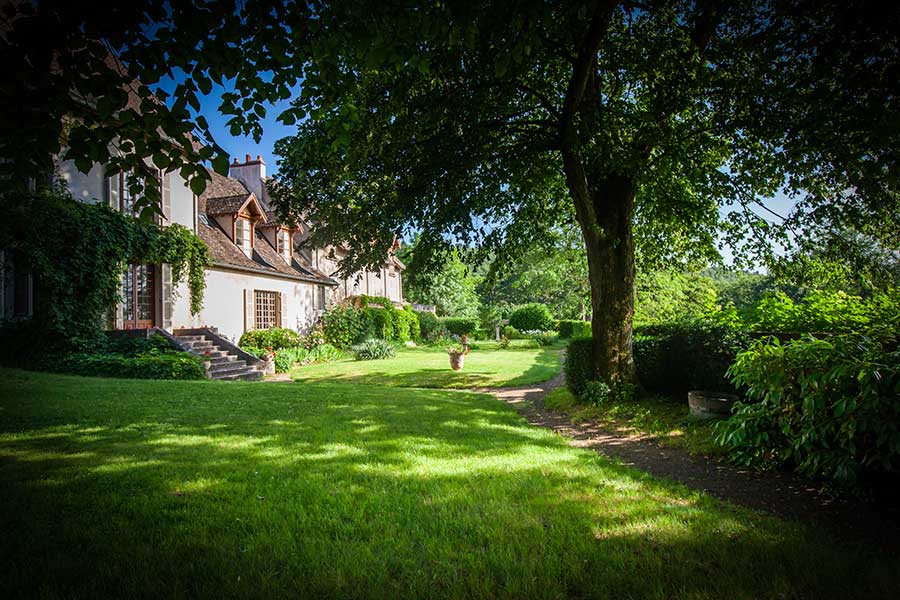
[717,334,900,485]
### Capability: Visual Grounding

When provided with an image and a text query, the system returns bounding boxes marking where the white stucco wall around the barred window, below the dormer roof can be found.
[172,269,318,342]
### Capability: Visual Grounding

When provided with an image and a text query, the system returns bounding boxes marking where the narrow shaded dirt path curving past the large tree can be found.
[474,375,900,553]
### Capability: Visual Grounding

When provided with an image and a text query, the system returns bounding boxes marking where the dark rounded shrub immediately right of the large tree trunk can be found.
[634,320,750,395]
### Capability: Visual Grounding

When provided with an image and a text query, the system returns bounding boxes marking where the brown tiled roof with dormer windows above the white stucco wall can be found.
[198,220,337,285]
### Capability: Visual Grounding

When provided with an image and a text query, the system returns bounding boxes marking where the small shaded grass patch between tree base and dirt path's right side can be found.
[544,388,725,456]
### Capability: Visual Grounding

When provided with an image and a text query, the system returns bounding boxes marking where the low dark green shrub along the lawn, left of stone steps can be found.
[54,349,206,379]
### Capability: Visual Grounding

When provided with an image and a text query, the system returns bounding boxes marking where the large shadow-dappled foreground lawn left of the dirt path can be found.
[0,370,900,598]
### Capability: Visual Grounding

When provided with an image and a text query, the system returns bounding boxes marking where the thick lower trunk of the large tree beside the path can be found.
[579,176,635,383]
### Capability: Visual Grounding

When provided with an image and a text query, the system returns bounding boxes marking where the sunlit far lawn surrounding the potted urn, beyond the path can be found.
[291,340,564,389]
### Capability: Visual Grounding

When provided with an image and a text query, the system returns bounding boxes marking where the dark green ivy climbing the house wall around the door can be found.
[0,188,211,354]
